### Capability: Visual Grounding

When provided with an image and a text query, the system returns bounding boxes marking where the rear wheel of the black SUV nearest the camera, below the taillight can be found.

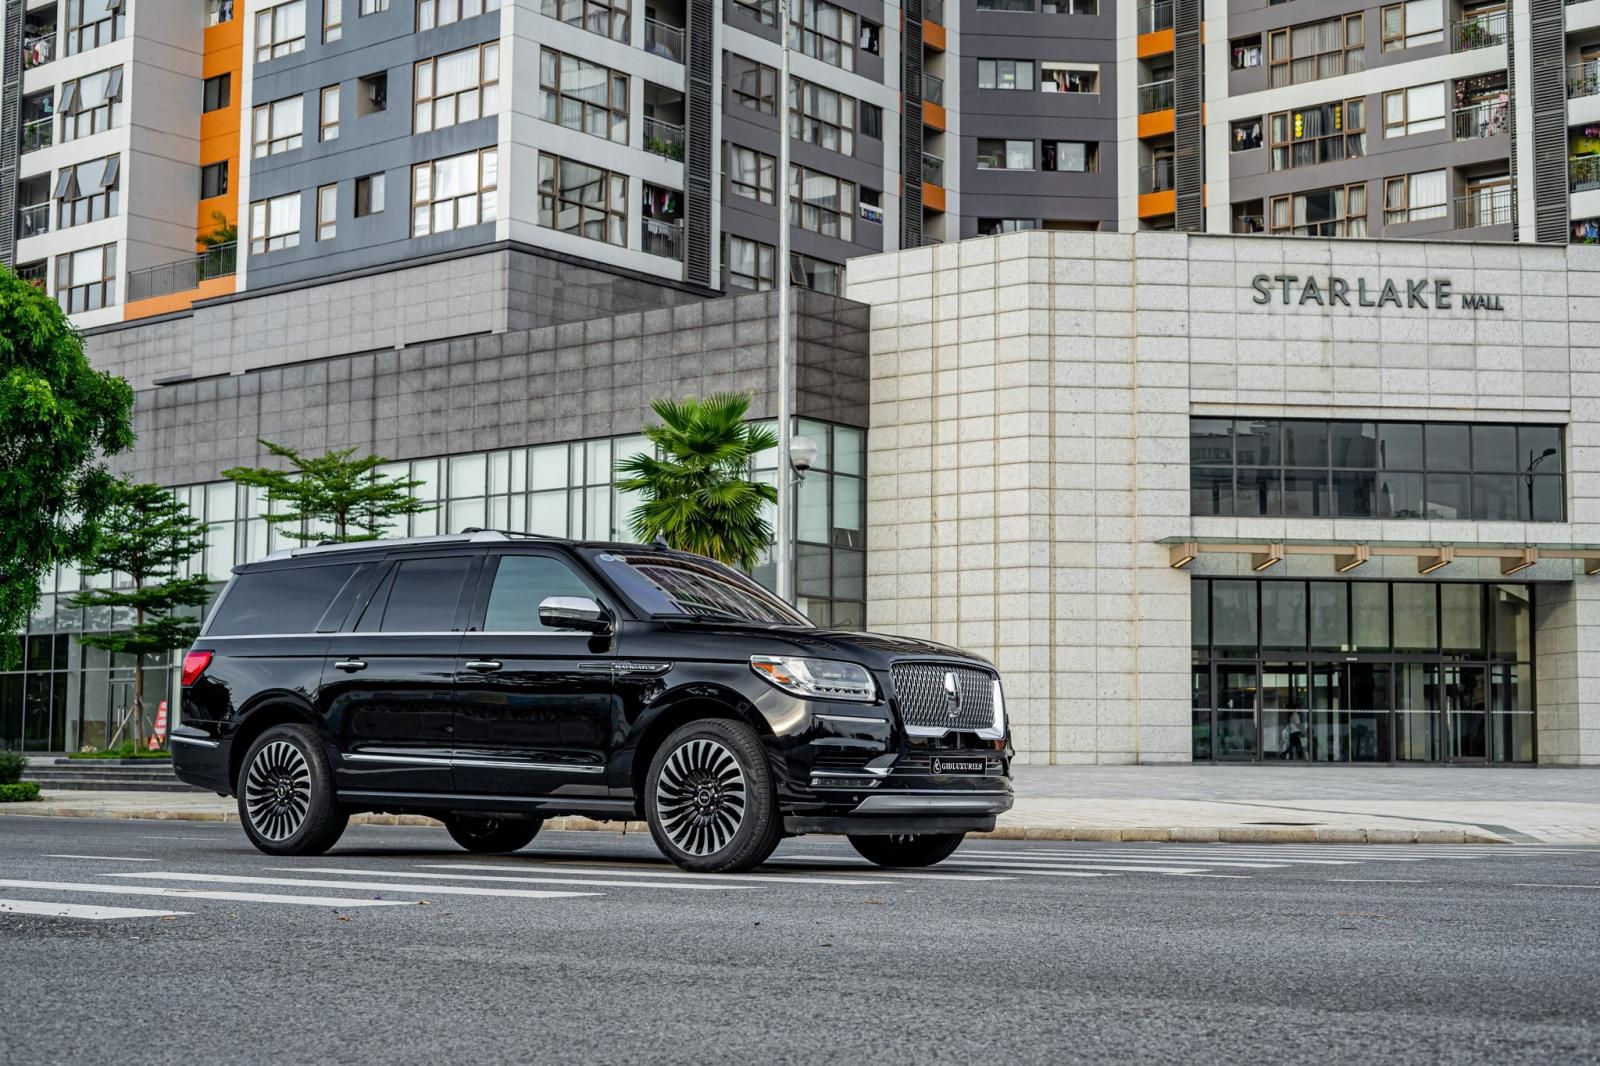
[237,725,350,855]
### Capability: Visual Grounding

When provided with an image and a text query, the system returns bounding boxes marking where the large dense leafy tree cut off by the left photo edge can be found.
[0,267,133,666]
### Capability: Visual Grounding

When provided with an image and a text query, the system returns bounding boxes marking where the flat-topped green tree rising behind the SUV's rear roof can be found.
[222,440,434,543]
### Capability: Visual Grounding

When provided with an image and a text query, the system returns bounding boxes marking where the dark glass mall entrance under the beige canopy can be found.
[1192,578,1538,763]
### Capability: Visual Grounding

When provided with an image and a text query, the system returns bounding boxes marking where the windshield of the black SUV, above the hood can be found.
[594,552,811,627]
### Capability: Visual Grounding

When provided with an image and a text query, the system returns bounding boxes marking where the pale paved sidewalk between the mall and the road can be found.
[0,765,1600,844]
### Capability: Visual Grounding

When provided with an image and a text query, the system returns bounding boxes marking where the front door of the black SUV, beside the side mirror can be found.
[454,547,626,795]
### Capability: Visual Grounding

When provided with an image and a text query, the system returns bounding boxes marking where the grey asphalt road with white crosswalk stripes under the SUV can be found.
[0,818,1600,1066]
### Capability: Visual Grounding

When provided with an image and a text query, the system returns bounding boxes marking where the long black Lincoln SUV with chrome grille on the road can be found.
[171,530,1011,871]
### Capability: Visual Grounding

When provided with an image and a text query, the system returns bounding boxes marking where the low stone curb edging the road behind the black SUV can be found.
[0,802,1510,844]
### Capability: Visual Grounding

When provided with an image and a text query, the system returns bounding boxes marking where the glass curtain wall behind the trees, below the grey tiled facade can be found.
[0,419,867,751]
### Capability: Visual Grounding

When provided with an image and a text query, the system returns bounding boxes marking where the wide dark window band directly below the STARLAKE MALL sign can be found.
[1189,418,1566,522]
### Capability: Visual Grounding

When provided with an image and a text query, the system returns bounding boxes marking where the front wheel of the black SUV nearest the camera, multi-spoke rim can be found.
[645,719,784,874]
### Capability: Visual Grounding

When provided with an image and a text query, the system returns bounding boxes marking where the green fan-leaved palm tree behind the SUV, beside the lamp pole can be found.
[616,392,778,570]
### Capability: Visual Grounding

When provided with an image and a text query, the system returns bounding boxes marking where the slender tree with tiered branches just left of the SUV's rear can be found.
[72,480,210,751]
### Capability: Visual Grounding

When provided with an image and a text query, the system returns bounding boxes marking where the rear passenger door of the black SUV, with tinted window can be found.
[318,552,482,792]
